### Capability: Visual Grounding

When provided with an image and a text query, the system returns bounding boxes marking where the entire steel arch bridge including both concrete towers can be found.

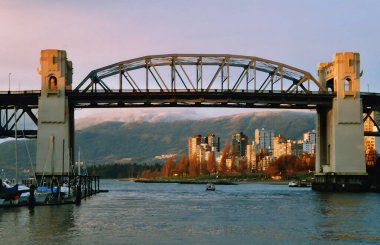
[0,49,380,191]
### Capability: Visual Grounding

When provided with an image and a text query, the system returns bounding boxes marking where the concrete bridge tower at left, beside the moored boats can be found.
[36,50,74,178]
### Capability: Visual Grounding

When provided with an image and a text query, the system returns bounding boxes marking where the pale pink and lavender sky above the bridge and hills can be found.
[0,0,380,116]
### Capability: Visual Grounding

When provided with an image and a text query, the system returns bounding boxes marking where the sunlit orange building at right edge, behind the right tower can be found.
[363,112,380,166]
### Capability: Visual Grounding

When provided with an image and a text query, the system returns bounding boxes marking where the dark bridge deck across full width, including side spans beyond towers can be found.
[0,90,380,137]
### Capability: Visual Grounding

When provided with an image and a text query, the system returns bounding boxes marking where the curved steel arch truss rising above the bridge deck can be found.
[74,54,327,94]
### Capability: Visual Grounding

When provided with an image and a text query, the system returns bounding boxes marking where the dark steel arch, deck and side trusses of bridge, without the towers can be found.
[0,54,380,137]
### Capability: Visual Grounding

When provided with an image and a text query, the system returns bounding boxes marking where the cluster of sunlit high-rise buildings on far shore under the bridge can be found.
[186,128,317,174]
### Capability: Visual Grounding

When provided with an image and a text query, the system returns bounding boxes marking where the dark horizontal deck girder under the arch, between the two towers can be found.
[68,90,334,109]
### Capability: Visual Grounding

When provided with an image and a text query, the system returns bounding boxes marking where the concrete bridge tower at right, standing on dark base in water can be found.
[313,52,368,191]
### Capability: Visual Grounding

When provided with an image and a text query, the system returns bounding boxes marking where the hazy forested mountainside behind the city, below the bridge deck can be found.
[0,111,315,173]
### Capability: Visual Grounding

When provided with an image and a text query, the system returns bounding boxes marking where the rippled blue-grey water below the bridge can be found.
[0,180,380,245]
